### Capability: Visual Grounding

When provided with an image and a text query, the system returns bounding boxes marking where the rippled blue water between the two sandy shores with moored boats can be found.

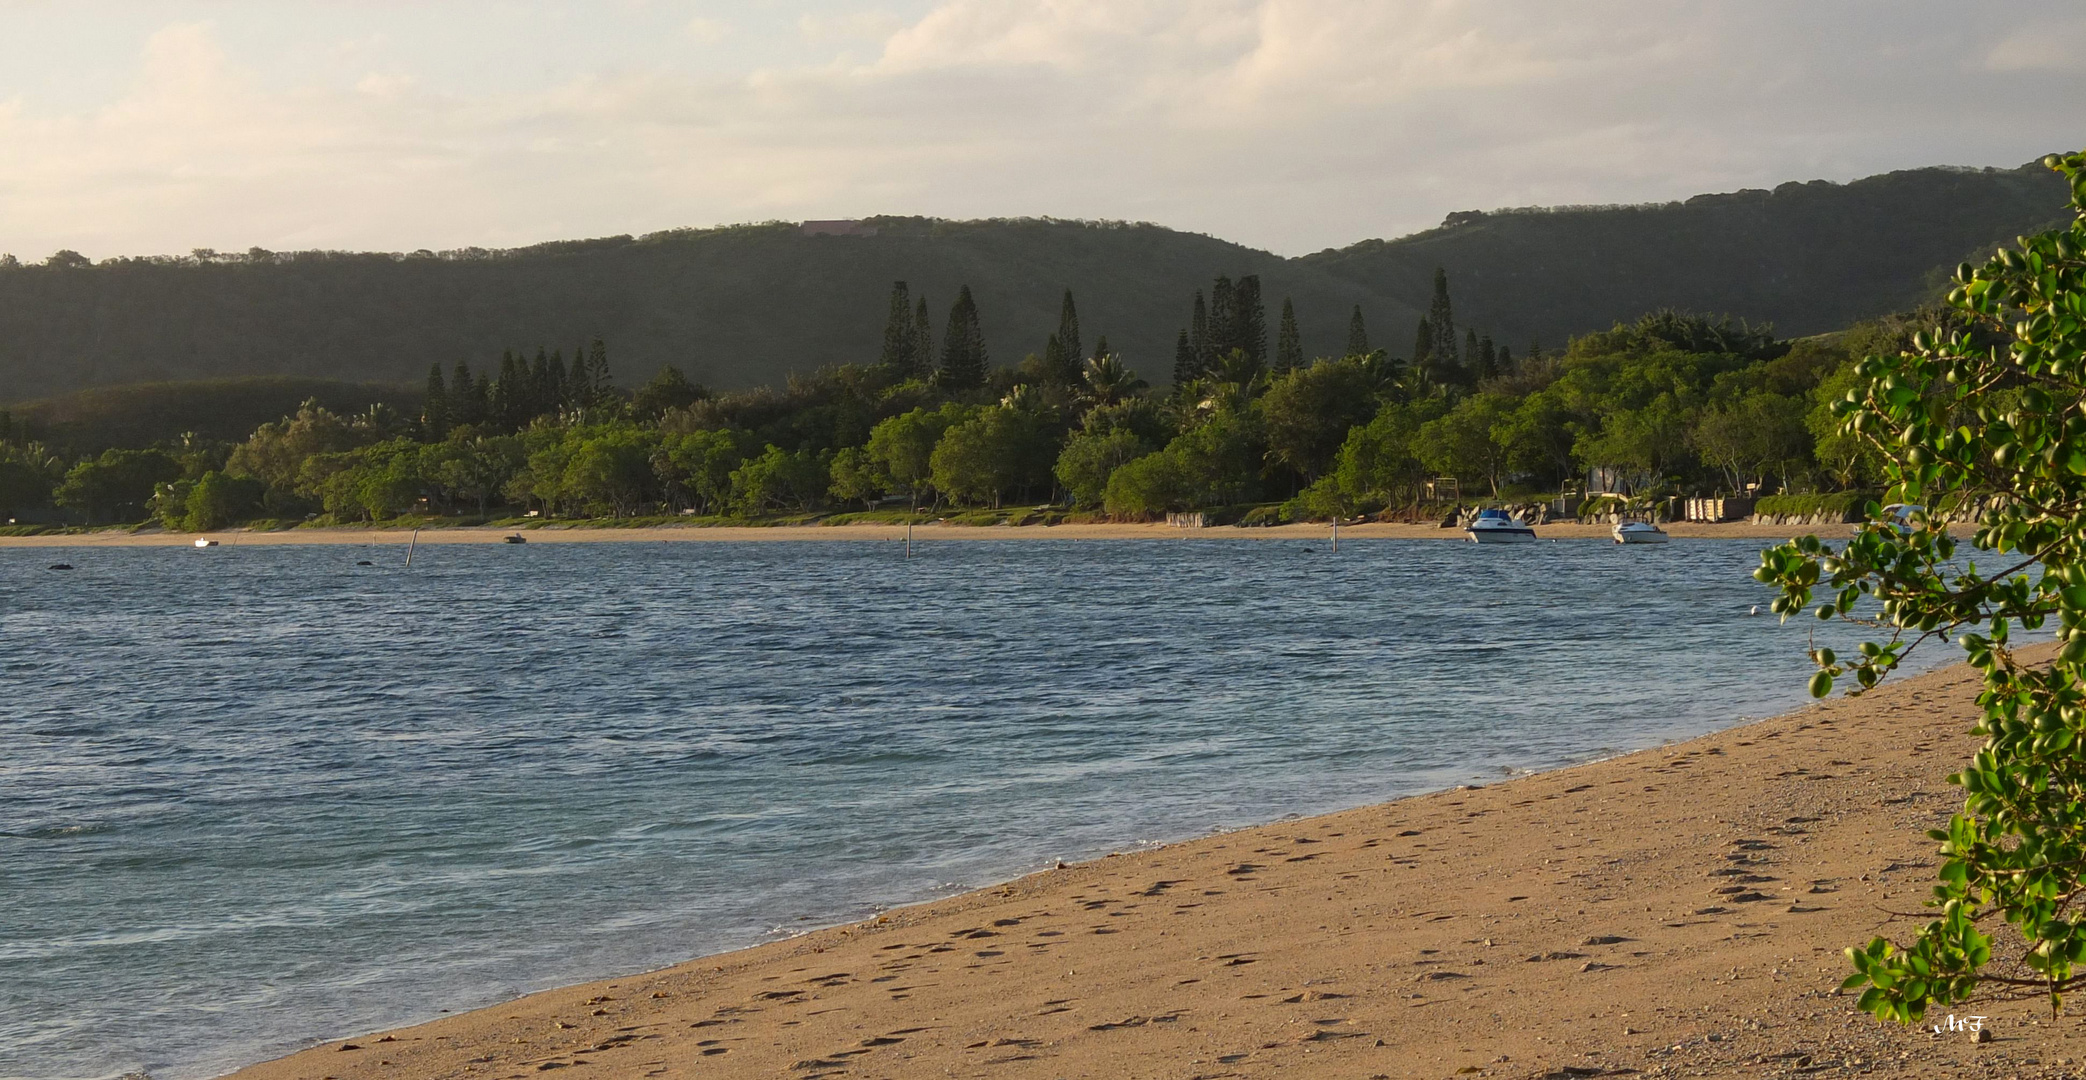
[0,538,1919,1080]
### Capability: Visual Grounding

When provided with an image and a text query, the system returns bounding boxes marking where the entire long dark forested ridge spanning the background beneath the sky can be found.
[0,158,2065,402]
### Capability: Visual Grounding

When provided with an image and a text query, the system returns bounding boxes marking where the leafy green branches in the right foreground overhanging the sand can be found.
[1754,154,2086,1024]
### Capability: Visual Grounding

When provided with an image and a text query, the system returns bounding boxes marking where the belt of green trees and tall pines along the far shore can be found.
[0,266,1923,530]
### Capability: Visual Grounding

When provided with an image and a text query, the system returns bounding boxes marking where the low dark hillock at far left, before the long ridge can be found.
[8,375,421,452]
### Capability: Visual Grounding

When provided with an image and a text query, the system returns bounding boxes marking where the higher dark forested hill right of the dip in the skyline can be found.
[1300,163,2069,350]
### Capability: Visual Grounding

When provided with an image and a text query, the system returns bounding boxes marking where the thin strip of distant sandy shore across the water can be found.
[0,521,1852,548]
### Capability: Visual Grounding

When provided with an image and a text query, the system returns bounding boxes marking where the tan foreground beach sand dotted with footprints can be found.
[236,646,2086,1080]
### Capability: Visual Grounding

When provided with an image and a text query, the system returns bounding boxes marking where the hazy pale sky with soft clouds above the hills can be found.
[0,0,2086,261]
